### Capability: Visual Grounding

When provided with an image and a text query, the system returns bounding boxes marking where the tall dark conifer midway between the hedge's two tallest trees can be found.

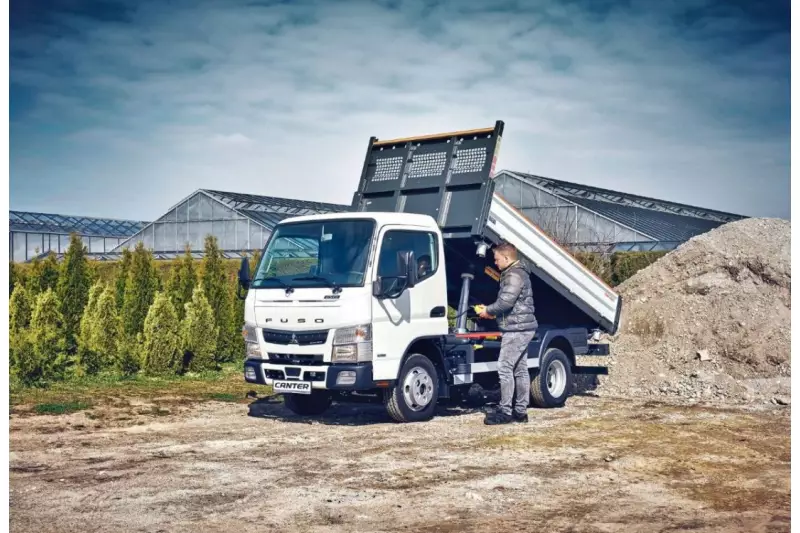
[122,241,158,336]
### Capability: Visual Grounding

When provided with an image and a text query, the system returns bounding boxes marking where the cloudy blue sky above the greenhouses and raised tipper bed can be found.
[10,0,790,220]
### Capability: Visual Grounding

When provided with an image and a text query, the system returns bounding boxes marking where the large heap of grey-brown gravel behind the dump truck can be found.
[598,219,791,404]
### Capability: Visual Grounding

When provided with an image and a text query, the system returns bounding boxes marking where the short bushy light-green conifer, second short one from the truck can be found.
[141,292,183,375]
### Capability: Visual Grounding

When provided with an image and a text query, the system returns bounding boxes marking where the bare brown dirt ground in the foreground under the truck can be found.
[10,388,790,533]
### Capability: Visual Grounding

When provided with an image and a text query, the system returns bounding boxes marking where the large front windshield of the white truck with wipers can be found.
[251,220,375,289]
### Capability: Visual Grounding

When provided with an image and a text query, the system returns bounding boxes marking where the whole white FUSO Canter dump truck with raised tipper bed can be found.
[239,121,622,422]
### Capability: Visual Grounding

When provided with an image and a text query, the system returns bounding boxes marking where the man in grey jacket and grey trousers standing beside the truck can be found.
[479,243,539,425]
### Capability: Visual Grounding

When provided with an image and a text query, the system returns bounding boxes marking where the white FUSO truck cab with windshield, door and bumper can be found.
[238,213,448,414]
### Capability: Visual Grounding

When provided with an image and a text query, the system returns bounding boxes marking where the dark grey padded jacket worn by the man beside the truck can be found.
[486,261,539,332]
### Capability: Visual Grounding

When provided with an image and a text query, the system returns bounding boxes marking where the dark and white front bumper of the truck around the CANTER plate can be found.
[244,359,375,391]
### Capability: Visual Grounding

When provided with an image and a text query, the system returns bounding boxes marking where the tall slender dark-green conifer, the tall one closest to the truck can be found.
[203,235,234,361]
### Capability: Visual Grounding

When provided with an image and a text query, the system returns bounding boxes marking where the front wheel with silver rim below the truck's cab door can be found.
[386,354,439,422]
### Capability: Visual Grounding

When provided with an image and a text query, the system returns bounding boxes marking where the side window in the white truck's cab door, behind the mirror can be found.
[378,230,439,281]
